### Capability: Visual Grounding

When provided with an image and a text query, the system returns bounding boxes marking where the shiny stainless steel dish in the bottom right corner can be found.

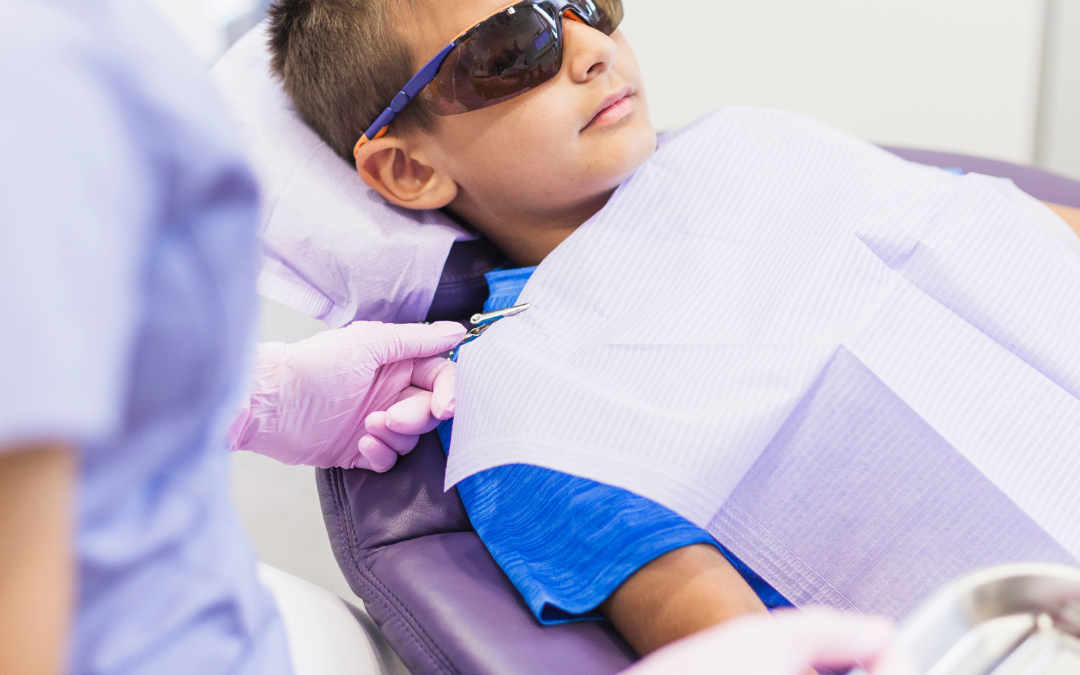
[855,564,1080,675]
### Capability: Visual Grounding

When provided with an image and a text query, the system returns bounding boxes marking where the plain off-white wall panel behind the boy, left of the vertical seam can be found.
[623,0,1045,162]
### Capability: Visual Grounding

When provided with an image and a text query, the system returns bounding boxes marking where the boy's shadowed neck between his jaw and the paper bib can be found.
[449,190,615,267]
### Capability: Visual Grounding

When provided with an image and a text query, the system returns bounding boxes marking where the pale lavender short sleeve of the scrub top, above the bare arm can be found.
[0,9,154,451]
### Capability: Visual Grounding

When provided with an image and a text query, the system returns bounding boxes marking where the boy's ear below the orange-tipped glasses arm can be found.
[356,136,458,210]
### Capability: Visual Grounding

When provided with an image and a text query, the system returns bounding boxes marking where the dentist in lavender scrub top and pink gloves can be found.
[0,0,900,675]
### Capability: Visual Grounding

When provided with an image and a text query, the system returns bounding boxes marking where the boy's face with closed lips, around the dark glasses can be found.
[367,0,657,262]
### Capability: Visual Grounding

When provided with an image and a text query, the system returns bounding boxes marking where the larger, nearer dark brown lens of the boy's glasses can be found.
[420,3,563,116]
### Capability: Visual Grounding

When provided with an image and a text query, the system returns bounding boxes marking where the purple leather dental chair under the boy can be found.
[316,148,1080,675]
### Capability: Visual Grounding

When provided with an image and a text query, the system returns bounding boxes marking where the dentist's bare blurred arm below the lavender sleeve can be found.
[0,446,75,675]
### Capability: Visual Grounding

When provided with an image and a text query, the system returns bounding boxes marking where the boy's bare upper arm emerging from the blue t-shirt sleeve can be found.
[600,544,767,656]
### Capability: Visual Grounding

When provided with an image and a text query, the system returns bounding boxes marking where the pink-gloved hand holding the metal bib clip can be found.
[229,322,465,472]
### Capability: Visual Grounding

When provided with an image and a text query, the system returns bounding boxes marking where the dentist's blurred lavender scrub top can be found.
[0,0,291,675]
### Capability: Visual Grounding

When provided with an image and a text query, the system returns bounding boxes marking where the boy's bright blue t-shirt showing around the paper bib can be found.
[438,267,791,623]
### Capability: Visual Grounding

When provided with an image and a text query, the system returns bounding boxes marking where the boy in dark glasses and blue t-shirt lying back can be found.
[263,0,1080,653]
